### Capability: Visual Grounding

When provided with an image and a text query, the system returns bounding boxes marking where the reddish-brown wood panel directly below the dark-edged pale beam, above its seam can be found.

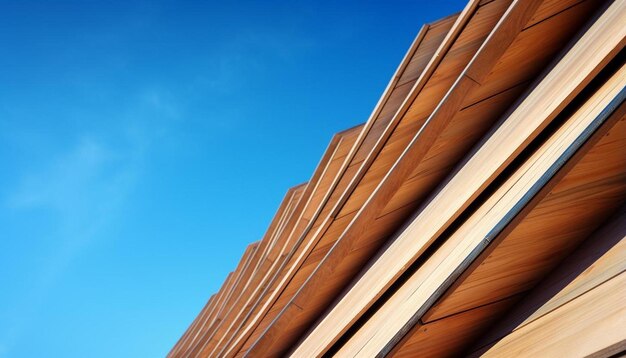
[423,98,626,322]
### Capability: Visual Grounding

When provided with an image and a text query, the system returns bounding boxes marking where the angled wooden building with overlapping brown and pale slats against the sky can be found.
[169,0,626,357]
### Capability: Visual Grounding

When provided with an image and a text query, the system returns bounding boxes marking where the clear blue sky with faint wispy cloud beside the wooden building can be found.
[0,0,464,357]
